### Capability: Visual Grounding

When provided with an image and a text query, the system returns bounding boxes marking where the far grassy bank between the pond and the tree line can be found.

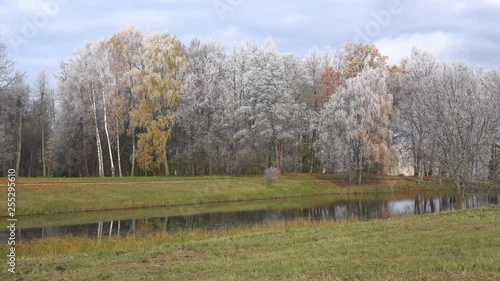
[0,175,444,216]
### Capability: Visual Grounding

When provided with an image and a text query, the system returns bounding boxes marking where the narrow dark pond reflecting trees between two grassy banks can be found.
[0,193,500,241]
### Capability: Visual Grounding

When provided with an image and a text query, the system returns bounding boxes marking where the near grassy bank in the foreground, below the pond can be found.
[7,206,500,280]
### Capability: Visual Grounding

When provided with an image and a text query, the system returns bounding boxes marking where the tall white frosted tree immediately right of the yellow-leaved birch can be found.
[178,39,236,174]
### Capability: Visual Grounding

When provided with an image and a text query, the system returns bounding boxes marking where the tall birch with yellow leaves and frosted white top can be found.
[131,32,186,175]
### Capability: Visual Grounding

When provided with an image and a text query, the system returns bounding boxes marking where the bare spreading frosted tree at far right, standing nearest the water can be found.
[425,62,500,197]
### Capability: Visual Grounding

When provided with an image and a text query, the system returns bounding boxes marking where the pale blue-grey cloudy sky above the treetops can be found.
[0,0,500,84]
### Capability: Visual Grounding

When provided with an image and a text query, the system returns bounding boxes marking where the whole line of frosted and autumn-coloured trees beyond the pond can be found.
[0,27,500,189]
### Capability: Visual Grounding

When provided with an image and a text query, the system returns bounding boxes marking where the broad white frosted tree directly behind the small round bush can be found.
[239,41,306,169]
